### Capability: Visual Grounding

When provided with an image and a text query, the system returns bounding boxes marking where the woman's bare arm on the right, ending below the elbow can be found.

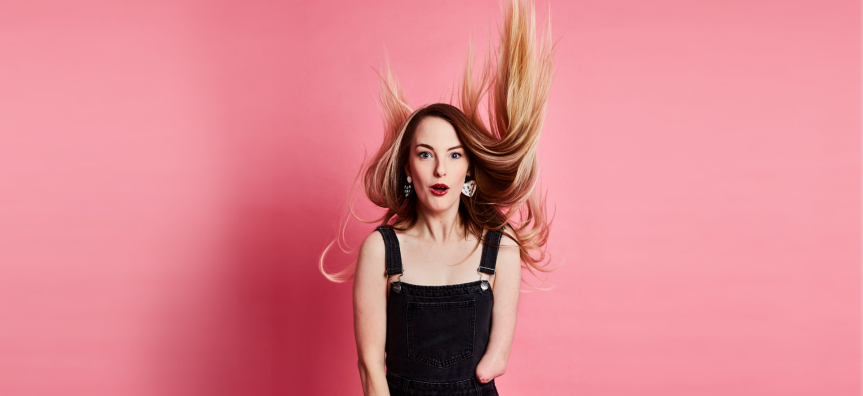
[476,235,521,383]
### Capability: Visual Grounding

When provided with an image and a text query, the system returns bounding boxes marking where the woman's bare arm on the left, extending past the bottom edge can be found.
[353,231,390,396]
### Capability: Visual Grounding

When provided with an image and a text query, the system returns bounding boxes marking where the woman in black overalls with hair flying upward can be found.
[324,0,553,396]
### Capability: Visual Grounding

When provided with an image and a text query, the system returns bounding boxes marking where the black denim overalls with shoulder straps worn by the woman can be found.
[375,226,501,396]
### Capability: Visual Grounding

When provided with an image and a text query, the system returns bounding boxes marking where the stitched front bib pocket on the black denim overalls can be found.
[407,300,476,367]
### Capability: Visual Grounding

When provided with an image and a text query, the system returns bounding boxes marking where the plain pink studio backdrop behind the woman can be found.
[0,0,861,396]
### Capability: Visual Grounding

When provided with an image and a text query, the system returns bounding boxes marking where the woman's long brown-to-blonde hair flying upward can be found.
[319,0,554,290]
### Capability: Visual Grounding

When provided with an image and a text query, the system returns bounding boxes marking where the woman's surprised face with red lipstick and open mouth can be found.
[405,116,468,212]
